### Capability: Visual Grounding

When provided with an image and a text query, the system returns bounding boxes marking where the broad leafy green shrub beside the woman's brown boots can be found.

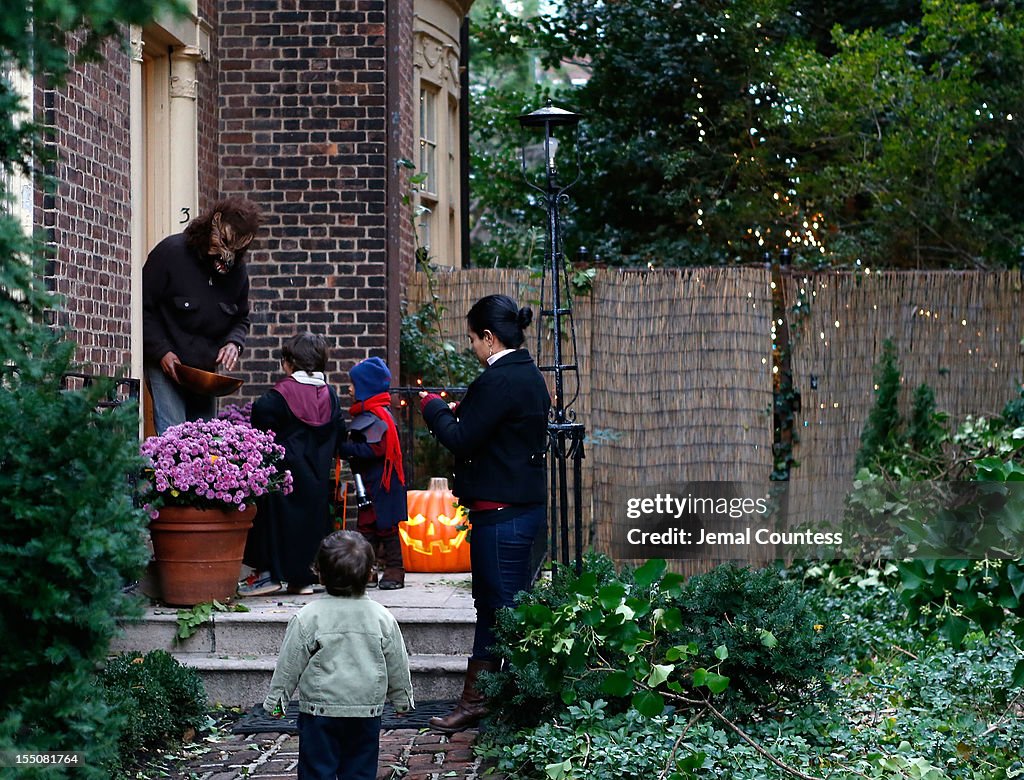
[484,555,838,728]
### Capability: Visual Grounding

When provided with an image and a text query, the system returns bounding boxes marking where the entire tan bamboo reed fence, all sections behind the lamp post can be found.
[407,268,1024,570]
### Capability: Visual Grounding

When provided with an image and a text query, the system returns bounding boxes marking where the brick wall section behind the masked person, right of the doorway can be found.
[217,0,399,399]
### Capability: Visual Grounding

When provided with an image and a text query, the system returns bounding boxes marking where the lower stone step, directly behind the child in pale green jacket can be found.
[174,653,466,709]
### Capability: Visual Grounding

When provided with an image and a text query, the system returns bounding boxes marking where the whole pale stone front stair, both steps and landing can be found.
[111,572,476,708]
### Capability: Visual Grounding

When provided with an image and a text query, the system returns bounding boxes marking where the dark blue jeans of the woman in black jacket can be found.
[469,504,547,660]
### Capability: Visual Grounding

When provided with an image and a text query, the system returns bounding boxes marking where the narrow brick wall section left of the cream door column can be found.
[36,35,131,375]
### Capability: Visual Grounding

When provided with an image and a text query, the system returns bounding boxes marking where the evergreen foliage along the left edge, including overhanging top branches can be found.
[0,0,183,780]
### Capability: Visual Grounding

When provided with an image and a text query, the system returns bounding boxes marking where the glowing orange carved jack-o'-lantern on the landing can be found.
[398,477,470,572]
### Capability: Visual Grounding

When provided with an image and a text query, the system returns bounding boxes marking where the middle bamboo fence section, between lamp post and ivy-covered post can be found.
[588,268,772,573]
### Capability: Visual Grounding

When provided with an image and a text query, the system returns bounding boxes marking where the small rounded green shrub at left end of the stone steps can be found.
[102,650,207,765]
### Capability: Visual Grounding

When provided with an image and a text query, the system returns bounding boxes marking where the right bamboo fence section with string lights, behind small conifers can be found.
[785,271,1024,524]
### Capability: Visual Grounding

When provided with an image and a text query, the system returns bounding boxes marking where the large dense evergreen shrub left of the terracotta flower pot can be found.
[0,329,148,778]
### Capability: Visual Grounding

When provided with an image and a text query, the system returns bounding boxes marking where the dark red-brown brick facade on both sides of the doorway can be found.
[36,0,414,401]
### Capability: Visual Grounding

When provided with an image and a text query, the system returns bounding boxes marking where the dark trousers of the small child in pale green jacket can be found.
[298,712,381,780]
